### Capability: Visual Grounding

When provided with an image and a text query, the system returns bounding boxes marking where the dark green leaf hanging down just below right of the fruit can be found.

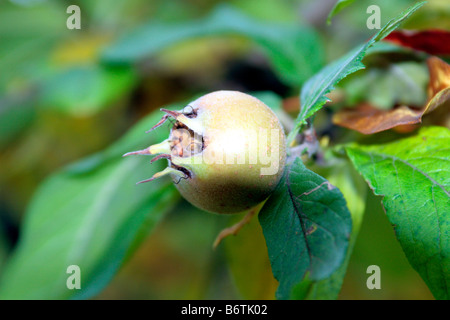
[259,158,352,299]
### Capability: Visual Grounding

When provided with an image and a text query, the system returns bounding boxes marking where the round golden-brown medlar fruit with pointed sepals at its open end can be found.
[126,91,286,214]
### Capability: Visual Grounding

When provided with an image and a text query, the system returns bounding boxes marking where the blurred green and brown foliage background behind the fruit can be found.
[0,0,450,299]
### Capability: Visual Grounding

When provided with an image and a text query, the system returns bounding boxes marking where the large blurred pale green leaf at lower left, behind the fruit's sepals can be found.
[0,108,179,299]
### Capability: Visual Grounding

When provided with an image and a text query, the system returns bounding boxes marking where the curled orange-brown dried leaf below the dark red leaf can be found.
[333,57,450,134]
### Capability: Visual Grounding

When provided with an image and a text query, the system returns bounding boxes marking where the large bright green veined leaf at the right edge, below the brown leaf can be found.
[346,127,450,299]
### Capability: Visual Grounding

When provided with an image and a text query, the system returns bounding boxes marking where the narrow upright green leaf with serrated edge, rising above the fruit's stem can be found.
[287,2,424,144]
